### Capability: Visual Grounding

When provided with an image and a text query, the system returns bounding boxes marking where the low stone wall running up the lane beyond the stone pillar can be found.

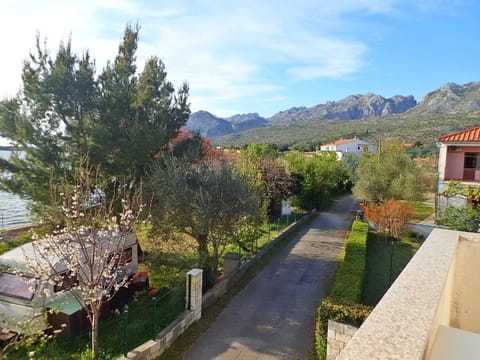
[202,213,316,308]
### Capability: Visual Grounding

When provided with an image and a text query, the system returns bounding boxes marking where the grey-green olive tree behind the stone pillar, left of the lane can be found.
[147,154,260,286]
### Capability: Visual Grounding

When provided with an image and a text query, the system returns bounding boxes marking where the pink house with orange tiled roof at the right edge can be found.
[437,126,480,210]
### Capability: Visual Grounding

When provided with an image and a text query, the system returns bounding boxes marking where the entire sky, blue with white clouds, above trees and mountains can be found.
[0,0,480,121]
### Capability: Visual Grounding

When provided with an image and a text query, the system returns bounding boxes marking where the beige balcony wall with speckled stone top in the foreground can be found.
[337,229,480,360]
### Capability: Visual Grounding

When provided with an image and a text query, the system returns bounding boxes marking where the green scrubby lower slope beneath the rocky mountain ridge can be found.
[213,111,480,150]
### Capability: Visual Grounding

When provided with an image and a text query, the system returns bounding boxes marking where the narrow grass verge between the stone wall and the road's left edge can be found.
[159,212,315,360]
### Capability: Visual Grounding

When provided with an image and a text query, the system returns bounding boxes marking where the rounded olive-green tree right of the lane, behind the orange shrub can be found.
[353,140,424,203]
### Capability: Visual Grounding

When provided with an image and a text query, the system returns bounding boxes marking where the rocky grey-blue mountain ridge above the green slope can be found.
[186,82,480,138]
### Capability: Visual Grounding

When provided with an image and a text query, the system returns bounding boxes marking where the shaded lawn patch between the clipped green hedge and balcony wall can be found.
[362,232,420,306]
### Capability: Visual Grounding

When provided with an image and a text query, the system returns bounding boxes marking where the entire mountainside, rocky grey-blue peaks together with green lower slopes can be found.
[187,82,480,147]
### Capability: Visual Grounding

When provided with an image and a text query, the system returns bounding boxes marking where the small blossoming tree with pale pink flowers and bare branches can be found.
[29,163,144,358]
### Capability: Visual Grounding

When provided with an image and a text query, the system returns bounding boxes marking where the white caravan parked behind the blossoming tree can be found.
[0,232,138,334]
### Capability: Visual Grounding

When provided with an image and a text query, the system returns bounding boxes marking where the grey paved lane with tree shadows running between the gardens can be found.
[184,196,356,360]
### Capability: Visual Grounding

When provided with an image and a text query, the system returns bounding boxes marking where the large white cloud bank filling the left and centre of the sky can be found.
[0,0,464,116]
